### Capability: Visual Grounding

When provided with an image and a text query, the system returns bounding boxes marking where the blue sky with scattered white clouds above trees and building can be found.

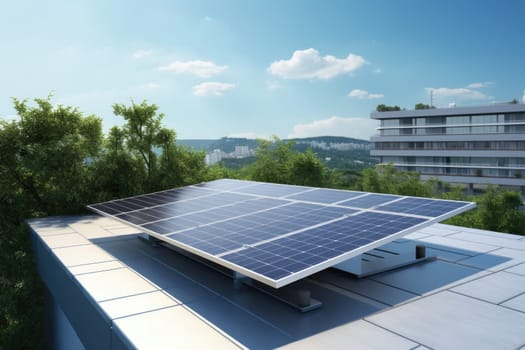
[0,0,525,139]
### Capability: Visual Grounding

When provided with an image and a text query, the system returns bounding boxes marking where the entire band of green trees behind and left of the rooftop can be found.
[0,97,525,349]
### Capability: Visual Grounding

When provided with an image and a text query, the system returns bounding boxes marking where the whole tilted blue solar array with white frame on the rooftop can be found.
[88,179,475,288]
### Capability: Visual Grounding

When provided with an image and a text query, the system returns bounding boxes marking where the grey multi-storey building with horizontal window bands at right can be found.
[370,103,525,191]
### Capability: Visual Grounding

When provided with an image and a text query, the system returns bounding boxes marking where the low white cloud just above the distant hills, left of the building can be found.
[288,116,378,140]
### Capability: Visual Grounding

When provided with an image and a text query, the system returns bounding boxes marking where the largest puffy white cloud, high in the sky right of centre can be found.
[268,48,366,79]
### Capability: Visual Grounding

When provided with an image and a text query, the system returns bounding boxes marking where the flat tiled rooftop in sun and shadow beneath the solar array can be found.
[29,215,525,350]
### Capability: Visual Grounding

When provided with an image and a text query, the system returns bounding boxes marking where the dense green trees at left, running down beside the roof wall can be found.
[0,97,208,349]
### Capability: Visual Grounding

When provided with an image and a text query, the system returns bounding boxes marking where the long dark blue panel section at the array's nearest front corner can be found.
[222,212,426,279]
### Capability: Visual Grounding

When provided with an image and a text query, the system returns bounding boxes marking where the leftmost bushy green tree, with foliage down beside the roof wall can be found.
[0,97,102,349]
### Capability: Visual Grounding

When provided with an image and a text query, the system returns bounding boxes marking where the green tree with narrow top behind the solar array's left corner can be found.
[93,101,207,201]
